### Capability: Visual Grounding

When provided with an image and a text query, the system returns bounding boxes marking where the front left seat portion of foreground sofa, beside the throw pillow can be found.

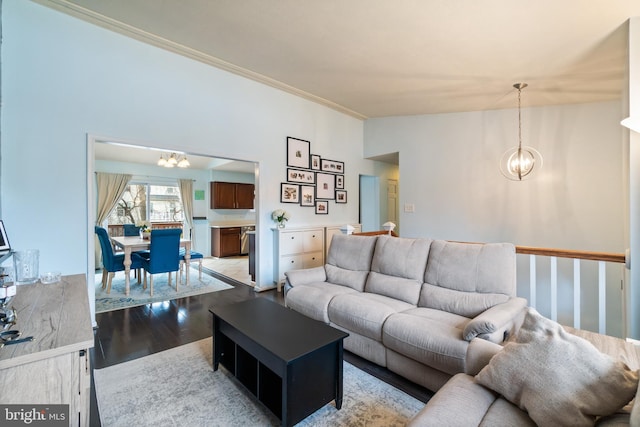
[407,374,497,427]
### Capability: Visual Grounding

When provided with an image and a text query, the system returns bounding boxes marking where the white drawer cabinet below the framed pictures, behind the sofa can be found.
[273,227,324,292]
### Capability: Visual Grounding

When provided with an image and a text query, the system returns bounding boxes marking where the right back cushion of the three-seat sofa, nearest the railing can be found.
[418,240,516,317]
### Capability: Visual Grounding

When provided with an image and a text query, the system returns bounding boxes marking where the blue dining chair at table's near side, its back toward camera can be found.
[131,228,182,296]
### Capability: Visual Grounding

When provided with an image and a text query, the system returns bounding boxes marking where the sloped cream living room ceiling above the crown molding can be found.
[41,0,640,118]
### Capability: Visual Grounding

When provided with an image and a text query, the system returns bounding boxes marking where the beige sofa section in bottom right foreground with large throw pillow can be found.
[408,309,640,427]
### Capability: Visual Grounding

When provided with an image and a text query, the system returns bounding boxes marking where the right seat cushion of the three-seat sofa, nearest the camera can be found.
[382,307,469,375]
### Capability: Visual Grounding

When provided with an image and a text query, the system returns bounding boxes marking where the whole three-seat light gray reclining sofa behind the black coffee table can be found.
[285,235,526,391]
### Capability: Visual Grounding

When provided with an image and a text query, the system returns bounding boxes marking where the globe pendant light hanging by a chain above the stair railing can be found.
[500,83,542,181]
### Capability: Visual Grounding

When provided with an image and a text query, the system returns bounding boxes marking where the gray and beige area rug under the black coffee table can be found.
[94,338,424,427]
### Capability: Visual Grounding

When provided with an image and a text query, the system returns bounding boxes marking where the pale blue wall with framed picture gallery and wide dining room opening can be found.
[1,1,373,320]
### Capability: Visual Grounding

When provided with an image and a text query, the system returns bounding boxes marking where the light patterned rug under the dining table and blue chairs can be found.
[95,268,233,313]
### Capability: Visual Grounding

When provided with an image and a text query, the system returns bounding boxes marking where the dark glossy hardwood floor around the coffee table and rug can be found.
[91,276,432,426]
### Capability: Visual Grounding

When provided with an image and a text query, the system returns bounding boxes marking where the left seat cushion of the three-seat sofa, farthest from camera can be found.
[285,282,356,323]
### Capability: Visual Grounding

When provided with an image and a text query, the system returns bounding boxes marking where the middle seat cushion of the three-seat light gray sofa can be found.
[328,293,414,342]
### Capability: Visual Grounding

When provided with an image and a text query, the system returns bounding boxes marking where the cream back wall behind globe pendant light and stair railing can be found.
[364,102,628,334]
